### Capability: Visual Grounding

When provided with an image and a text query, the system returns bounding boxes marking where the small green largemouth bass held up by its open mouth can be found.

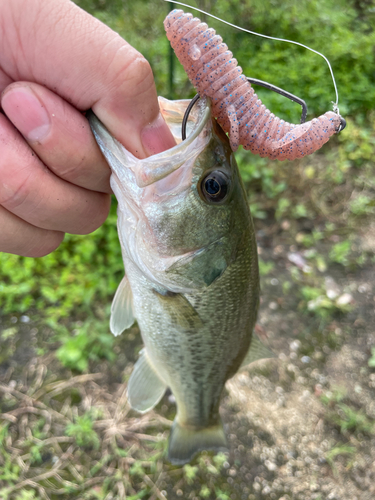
[89,97,270,465]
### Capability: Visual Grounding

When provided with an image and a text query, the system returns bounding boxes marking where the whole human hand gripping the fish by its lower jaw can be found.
[0,0,174,257]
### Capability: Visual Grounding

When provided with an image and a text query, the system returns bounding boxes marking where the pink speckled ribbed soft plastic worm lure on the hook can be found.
[164,9,343,160]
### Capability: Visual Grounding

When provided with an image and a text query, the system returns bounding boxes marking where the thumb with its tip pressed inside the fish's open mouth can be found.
[0,0,175,158]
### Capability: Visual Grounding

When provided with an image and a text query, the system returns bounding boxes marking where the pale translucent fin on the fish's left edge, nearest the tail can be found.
[128,349,167,413]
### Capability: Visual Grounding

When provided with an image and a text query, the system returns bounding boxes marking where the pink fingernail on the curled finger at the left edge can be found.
[1,87,51,142]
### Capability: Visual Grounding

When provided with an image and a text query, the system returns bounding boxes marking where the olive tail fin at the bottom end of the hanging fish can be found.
[168,420,228,465]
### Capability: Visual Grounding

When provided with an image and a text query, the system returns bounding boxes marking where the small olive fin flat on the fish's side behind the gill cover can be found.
[154,290,203,330]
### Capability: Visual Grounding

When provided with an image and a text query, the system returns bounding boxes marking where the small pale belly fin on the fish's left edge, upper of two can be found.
[109,276,135,337]
